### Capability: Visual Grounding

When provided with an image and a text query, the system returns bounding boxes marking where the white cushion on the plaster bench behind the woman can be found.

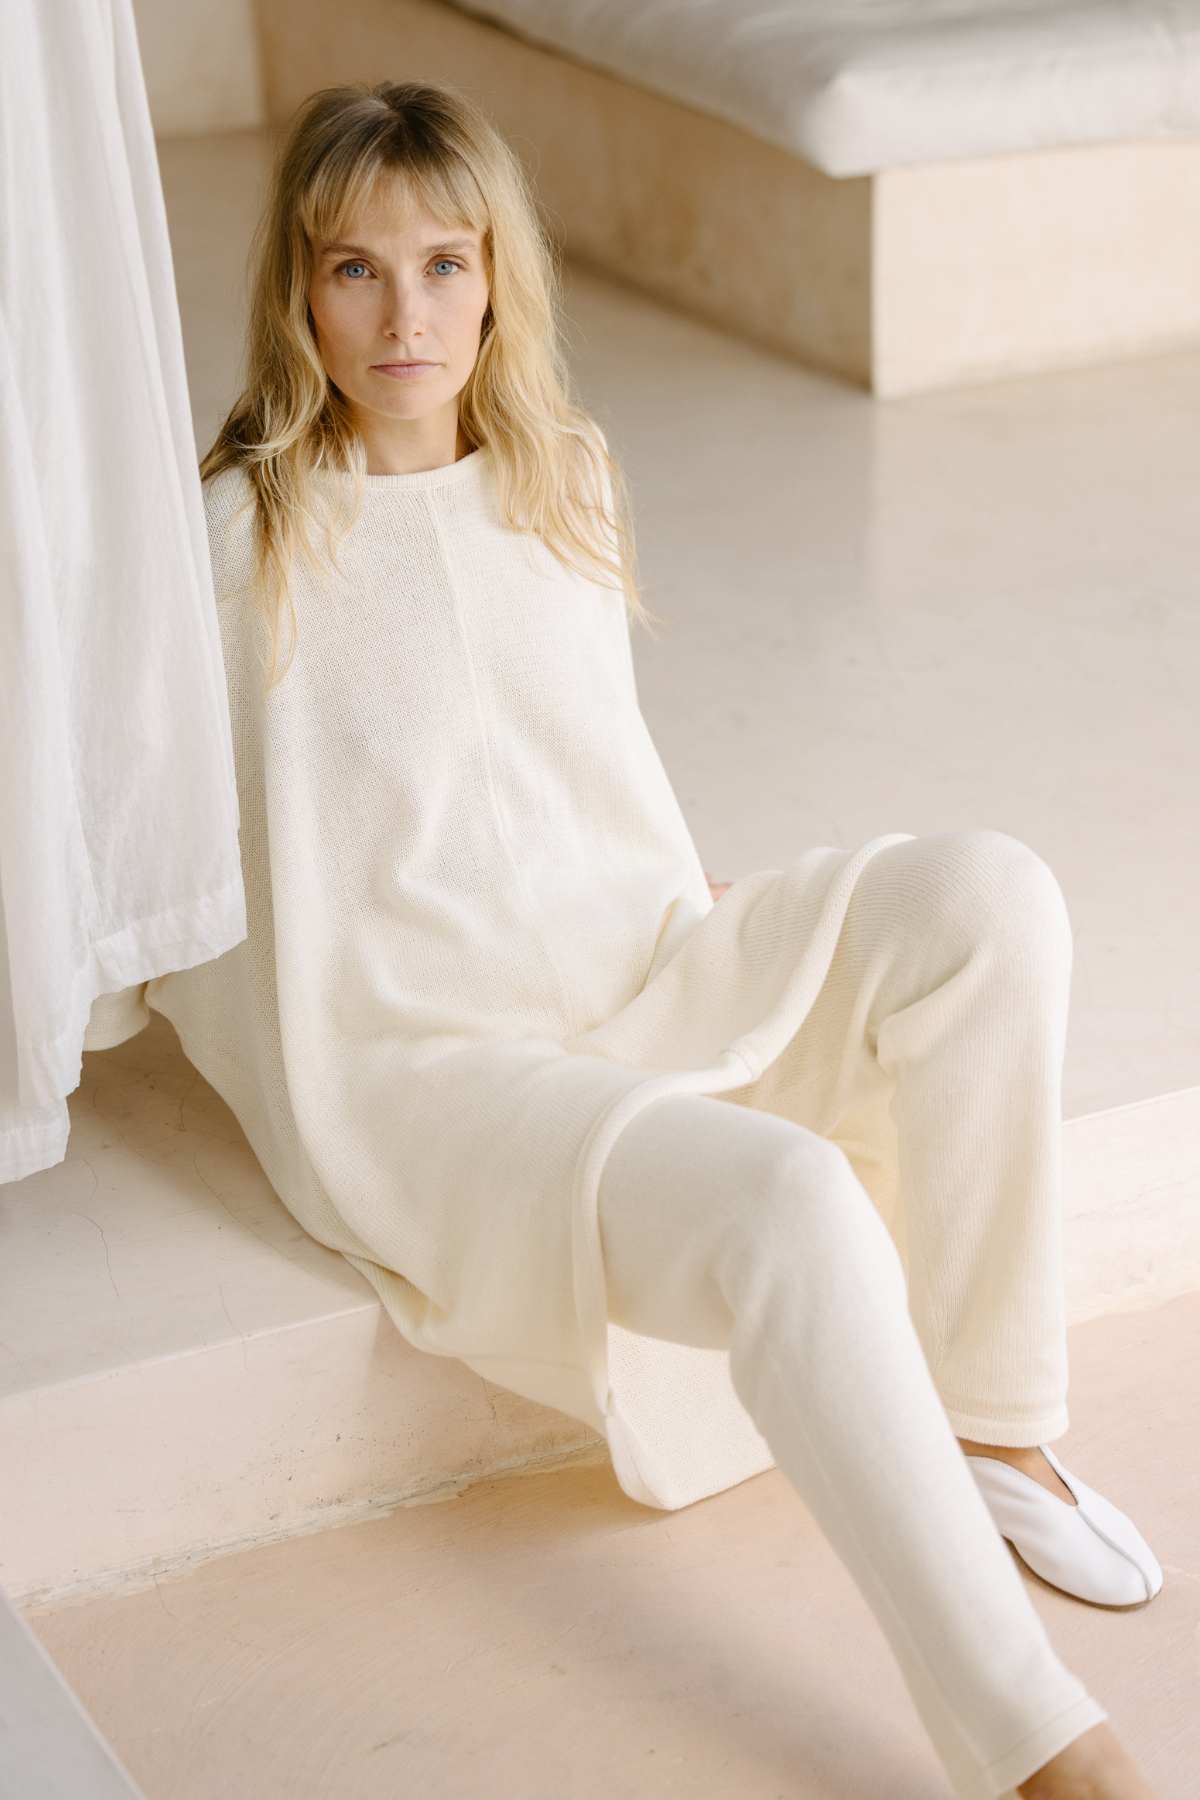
[452,0,1200,175]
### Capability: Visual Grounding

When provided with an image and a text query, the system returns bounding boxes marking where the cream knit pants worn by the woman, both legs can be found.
[599,830,1108,1800]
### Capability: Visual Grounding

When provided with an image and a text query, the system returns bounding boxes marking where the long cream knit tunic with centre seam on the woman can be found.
[85,446,910,1508]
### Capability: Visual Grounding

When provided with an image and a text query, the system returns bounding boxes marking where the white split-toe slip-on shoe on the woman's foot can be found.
[966,1444,1162,1607]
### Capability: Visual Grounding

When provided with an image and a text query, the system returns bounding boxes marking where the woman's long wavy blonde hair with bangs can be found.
[200,81,657,688]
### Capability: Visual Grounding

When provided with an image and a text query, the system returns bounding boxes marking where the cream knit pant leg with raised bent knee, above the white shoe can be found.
[748,830,1072,1445]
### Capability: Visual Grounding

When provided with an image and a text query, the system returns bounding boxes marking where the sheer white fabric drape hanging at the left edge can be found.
[0,0,246,1181]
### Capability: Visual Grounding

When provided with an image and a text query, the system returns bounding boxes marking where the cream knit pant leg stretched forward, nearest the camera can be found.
[599,1094,1108,1800]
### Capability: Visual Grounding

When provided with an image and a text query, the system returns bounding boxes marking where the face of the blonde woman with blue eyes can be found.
[308,191,488,448]
